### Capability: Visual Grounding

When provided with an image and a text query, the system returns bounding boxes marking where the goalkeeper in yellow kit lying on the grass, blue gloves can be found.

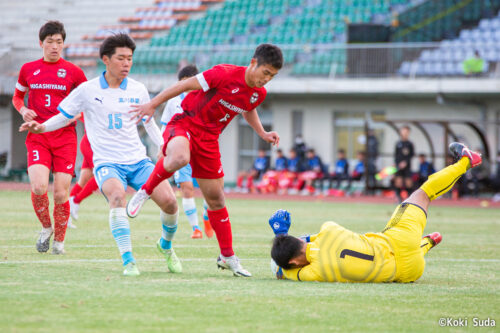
[269,142,482,283]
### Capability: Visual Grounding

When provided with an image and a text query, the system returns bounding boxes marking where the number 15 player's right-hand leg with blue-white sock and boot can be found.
[151,180,182,273]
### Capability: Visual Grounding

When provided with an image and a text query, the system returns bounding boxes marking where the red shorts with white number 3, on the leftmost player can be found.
[26,126,77,175]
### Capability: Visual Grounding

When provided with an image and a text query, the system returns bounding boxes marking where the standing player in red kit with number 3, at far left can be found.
[12,21,87,254]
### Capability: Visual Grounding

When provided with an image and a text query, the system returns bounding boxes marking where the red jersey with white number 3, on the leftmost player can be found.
[16,58,87,123]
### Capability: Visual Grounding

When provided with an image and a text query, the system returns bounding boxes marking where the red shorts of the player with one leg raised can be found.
[163,118,224,179]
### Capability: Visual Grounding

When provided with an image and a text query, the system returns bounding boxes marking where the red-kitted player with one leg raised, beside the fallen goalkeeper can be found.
[127,44,283,277]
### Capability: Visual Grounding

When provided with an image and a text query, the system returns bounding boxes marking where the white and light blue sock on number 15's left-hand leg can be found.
[109,208,135,266]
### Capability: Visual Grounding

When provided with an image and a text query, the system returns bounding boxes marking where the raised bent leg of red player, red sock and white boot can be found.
[127,136,191,217]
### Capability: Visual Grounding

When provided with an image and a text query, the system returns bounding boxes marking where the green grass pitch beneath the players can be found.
[0,191,500,332]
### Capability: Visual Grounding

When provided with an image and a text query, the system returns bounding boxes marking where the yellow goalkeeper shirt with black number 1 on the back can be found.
[283,222,396,282]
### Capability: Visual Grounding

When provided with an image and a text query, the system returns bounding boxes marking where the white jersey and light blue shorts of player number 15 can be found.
[58,73,160,188]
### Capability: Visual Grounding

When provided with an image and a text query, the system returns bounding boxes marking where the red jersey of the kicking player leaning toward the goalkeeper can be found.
[178,65,267,134]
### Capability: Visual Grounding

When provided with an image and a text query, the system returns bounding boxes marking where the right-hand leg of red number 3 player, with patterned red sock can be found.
[52,172,73,254]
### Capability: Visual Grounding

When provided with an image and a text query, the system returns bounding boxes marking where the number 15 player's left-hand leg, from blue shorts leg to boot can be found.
[95,165,140,276]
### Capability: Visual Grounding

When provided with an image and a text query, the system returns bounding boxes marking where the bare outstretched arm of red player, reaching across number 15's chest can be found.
[130,77,202,123]
